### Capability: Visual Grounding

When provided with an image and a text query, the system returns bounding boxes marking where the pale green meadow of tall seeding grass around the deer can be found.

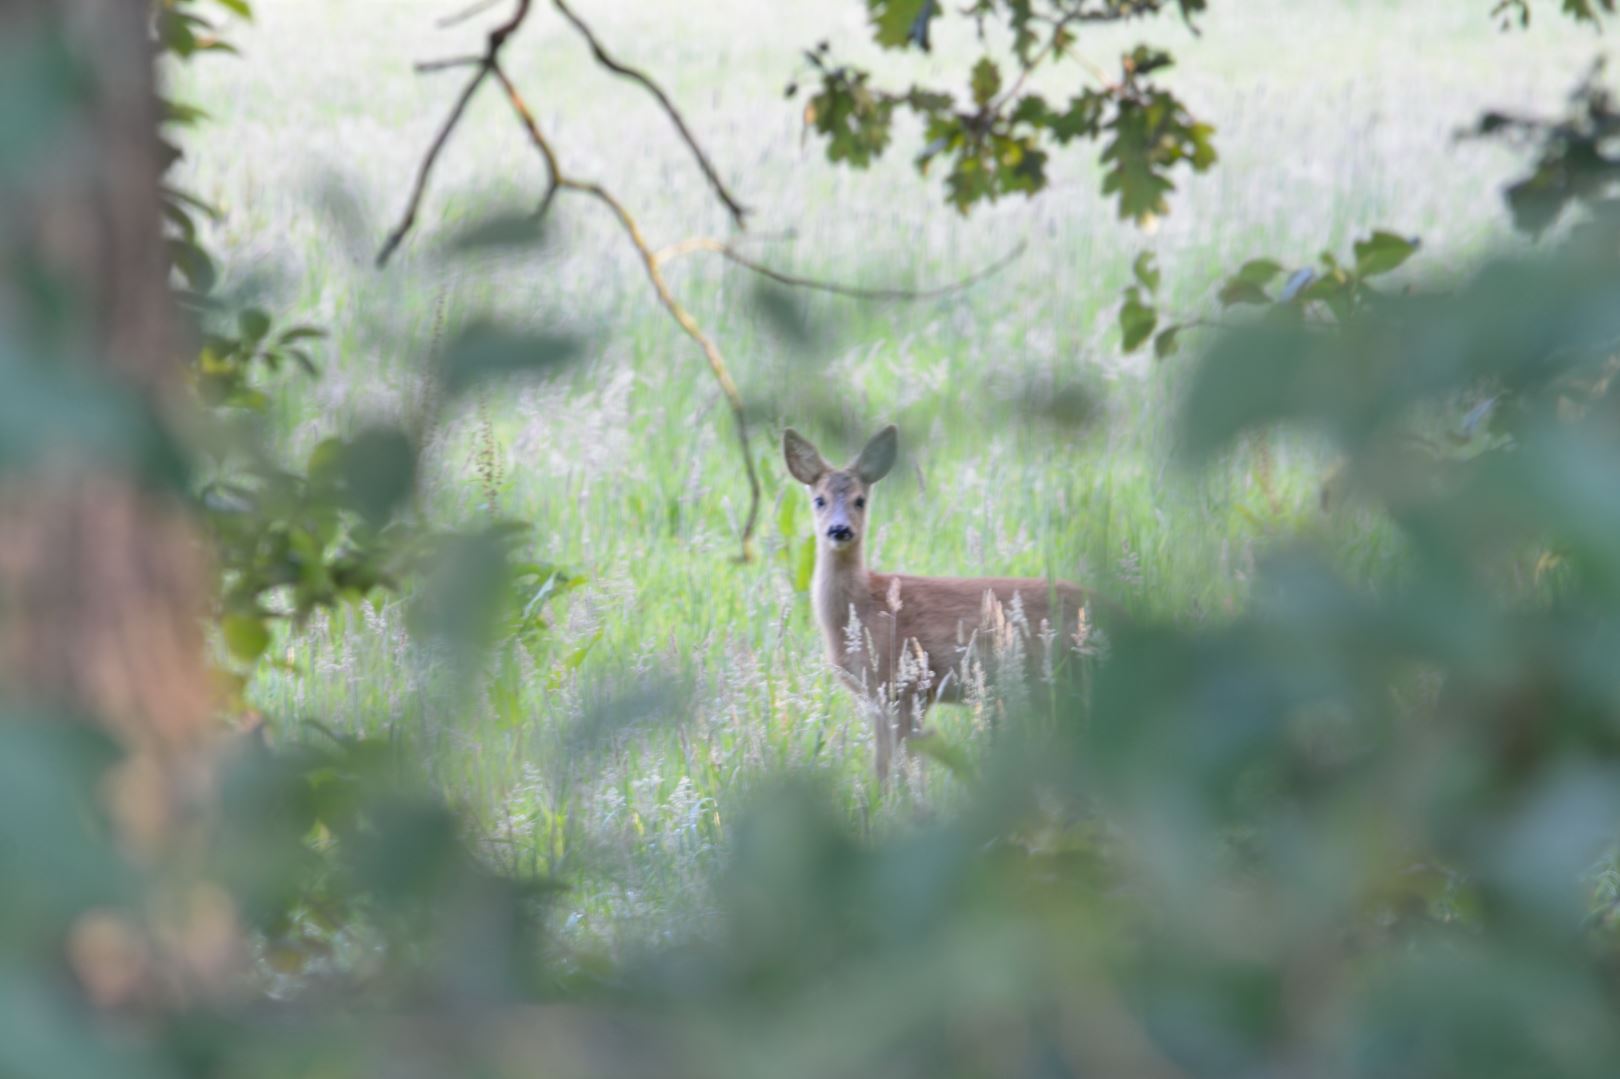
[167,0,1597,948]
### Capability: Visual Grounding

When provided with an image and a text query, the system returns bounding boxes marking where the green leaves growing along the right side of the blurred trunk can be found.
[154,0,580,682]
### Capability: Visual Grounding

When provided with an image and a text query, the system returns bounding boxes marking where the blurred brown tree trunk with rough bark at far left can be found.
[0,0,212,761]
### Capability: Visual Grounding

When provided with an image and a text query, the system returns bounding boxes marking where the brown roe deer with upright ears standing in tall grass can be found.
[782,426,1087,781]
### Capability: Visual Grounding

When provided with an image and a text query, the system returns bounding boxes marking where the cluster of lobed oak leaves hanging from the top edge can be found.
[787,0,1215,222]
